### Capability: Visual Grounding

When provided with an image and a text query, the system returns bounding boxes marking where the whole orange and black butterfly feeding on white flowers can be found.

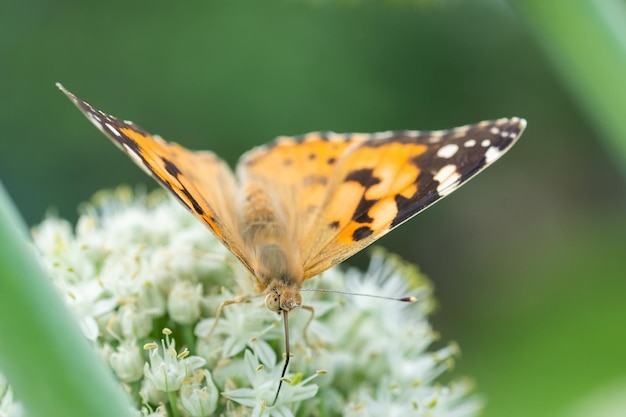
[57,84,526,402]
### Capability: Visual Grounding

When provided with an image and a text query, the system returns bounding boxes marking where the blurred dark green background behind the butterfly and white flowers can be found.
[0,0,626,416]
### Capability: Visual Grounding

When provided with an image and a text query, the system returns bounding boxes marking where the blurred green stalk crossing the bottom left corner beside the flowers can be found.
[0,184,132,417]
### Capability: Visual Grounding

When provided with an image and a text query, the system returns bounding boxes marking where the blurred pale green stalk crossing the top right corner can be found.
[513,0,626,175]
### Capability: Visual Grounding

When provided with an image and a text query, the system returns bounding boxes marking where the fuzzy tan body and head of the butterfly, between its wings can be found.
[241,184,304,312]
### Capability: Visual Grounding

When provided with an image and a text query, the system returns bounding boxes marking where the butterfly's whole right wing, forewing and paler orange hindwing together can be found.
[237,118,526,279]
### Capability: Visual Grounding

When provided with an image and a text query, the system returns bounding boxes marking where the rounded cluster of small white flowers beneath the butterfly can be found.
[0,188,481,417]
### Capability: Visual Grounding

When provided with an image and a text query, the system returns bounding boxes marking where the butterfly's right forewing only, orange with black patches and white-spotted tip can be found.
[299,118,526,279]
